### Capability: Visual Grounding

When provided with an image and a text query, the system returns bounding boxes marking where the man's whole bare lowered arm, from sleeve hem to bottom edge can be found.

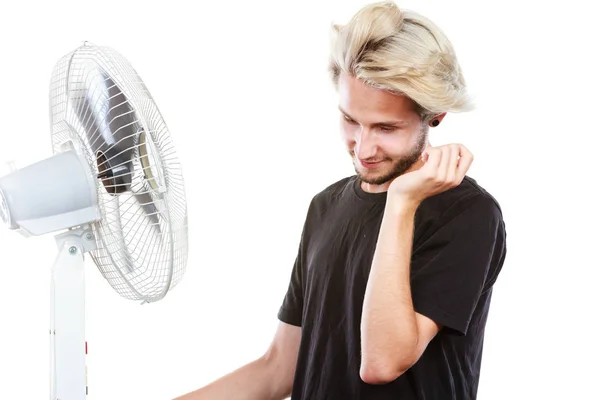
[174,322,301,400]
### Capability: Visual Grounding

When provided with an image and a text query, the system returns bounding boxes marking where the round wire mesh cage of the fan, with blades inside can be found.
[50,43,188,302]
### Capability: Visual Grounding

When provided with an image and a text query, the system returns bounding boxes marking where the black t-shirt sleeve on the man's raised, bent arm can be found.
[411,195,505,335]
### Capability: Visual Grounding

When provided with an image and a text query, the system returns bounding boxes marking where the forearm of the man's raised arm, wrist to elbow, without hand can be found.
[361,202,418,375]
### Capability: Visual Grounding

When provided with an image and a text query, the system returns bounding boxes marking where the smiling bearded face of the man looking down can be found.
[338,74,427,191]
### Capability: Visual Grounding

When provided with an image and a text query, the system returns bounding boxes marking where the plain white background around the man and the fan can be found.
[0,0,600,400]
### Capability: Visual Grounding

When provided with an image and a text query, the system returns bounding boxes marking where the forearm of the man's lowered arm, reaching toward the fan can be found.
[174,357,287,400]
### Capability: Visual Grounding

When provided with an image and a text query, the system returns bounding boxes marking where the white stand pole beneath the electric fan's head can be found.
[50,227,94,400]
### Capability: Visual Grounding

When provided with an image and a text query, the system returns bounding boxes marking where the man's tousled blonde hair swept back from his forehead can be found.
[328,1,473,122]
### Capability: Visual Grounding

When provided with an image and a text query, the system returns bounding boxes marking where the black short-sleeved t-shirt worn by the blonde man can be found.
[278,176,506,400]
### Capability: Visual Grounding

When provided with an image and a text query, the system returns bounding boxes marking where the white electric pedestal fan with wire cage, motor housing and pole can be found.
[0,42,188,400]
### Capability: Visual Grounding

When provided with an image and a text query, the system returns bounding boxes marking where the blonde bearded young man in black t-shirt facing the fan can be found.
[179,3,506,400]
